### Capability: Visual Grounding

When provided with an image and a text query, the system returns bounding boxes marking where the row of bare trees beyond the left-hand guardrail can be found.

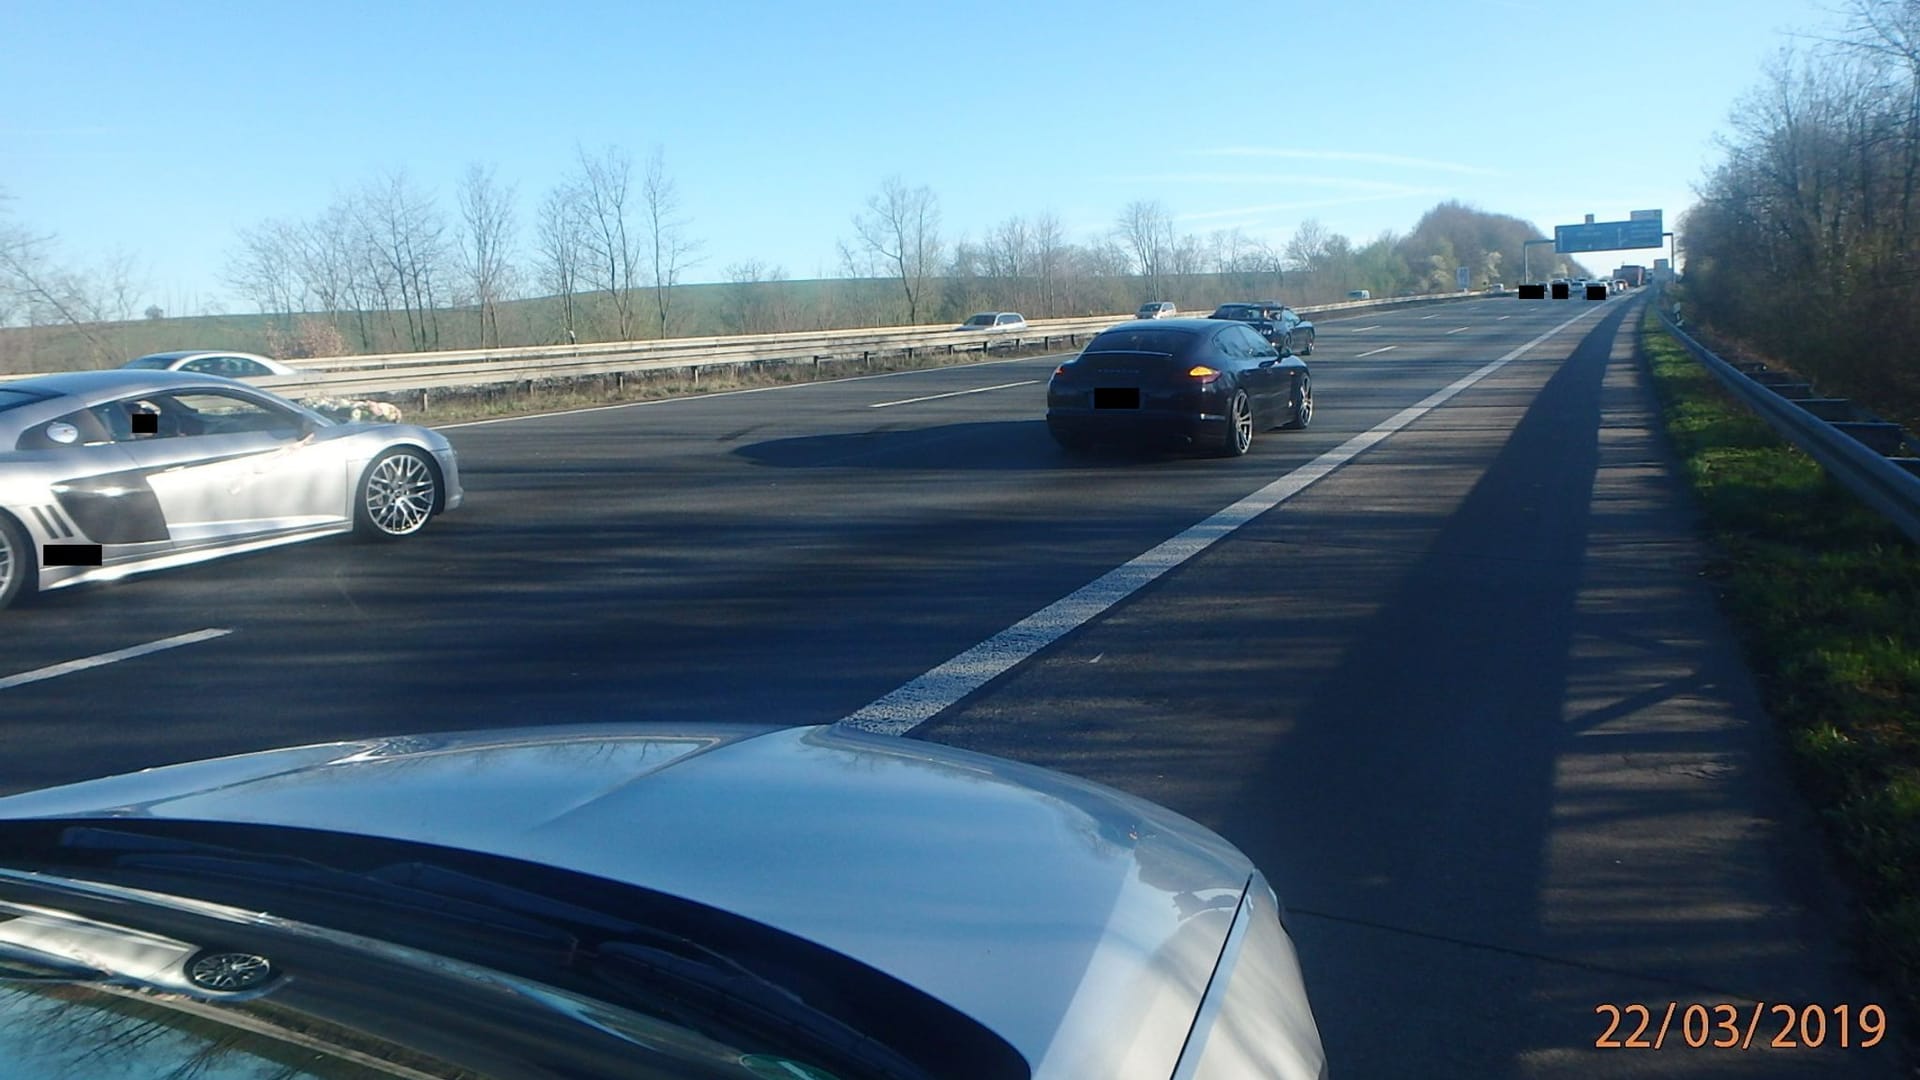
[0,148,1589,363]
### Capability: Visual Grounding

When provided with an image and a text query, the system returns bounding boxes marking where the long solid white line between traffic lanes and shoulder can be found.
[839,311,1586,734]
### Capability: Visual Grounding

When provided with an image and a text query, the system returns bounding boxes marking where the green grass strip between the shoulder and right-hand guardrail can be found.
[1642,309,1920,1020]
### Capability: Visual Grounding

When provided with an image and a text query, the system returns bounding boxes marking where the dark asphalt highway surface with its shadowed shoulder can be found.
[0,296,1905,1078]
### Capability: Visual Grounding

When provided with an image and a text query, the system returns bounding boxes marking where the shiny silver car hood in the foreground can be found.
[0,724,1321,1080]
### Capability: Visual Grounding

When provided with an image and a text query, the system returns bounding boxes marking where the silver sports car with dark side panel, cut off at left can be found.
[0,369,461,607]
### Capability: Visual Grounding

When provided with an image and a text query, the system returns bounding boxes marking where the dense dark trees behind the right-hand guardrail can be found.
[1680,0,1920,427]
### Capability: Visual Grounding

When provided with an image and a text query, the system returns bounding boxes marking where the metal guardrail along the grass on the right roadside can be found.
[1659,309,1920,544]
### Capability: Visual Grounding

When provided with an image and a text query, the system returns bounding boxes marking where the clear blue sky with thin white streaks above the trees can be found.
[0,0,1834,313]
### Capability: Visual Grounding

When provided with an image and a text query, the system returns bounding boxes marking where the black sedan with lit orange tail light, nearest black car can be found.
[1046,319,1313,457]
